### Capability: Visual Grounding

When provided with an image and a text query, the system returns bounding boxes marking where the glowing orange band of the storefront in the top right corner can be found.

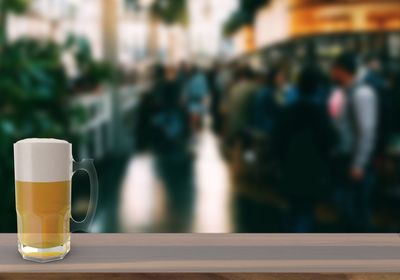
[289,0,400,37]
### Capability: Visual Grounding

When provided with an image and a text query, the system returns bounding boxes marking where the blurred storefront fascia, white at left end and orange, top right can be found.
[232,0,400,56]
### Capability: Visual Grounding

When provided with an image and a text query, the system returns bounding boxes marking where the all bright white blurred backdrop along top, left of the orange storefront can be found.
[8,0,238,65]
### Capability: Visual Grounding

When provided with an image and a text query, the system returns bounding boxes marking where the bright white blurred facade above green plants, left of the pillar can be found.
[8,0,103,59]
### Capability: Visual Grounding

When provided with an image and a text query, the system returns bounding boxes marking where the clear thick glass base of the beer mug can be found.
[18,240,71,263]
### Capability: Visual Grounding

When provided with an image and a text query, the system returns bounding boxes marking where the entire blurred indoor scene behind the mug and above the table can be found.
[0,0,400,233]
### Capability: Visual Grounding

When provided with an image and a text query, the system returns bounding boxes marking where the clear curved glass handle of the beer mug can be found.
[71,159,99,232]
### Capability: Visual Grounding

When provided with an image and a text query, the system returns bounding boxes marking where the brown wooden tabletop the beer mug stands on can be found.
[0,234,400,280]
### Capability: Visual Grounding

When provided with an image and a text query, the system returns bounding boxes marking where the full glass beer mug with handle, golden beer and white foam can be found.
[14,139,98,262]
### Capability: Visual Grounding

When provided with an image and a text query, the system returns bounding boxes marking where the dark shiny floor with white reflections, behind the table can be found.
[73,123,399,233]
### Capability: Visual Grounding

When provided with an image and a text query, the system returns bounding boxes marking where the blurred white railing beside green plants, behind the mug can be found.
[70,85,146,159]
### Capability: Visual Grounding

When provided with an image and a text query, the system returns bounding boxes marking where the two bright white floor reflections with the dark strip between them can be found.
[118,130,232,232]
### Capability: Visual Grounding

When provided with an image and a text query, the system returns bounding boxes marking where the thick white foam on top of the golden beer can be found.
[14,138,72,182]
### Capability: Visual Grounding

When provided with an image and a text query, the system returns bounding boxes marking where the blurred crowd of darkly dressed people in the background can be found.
[135,49,400,232]
